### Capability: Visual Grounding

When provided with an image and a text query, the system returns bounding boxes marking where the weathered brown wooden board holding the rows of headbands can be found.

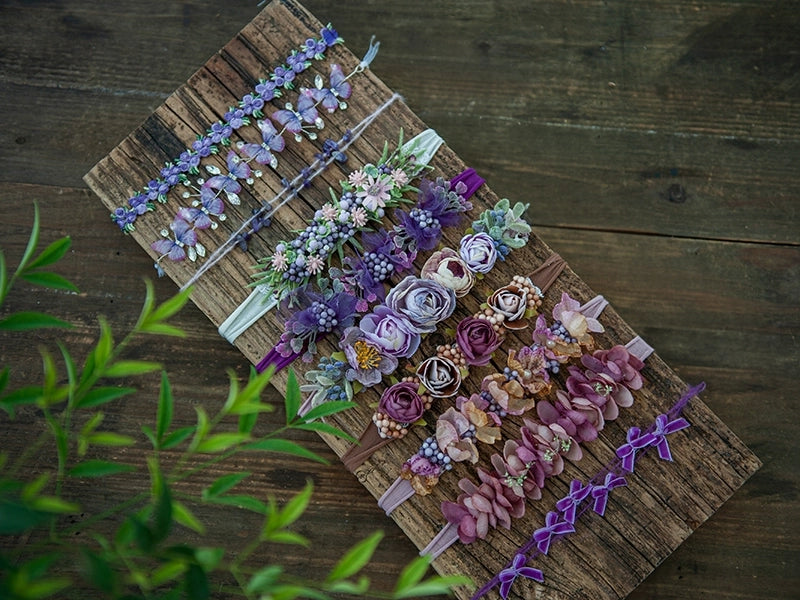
[86,2,760,598]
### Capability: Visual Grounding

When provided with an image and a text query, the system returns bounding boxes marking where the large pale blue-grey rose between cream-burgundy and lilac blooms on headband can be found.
[386,275,456,333]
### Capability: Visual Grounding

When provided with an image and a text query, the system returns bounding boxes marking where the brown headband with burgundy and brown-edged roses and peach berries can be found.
[341,258,565,471]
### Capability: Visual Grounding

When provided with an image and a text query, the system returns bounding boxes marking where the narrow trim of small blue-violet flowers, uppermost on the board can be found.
[111,24,344,233]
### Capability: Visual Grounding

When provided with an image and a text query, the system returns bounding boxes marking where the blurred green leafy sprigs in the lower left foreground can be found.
[0,208,467,600]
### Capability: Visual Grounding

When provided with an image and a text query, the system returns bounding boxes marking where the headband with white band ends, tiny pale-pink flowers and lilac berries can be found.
[219,129,454,343]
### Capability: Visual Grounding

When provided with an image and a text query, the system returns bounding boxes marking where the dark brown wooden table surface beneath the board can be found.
[0,0,800,599]
